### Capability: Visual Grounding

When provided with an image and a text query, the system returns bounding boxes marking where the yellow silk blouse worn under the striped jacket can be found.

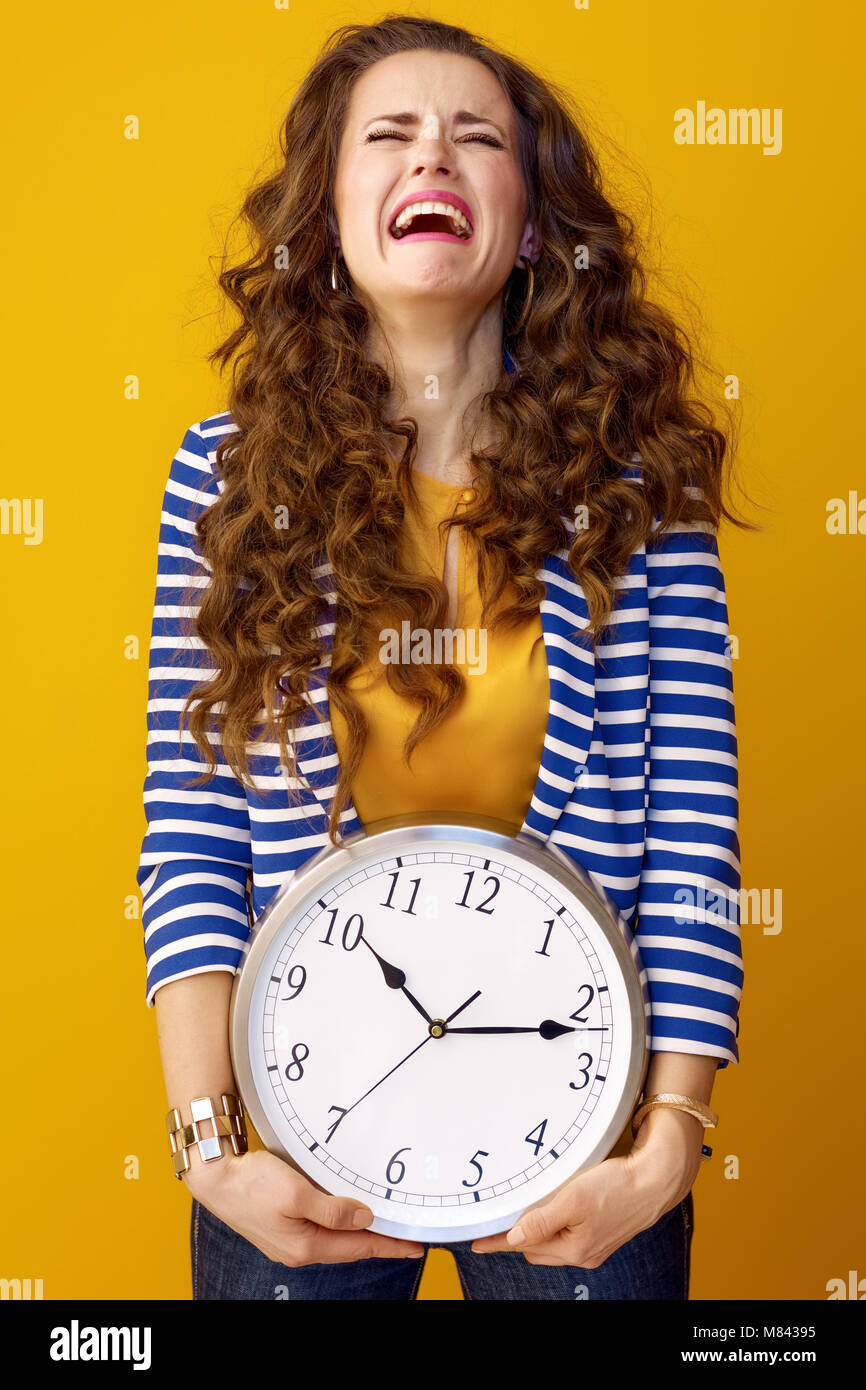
[331,470,549,828]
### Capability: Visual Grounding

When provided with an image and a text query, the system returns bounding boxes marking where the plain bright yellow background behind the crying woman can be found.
[0,0,866,1300]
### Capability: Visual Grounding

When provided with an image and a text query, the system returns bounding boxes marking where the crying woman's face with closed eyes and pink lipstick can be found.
[334,50,539,318]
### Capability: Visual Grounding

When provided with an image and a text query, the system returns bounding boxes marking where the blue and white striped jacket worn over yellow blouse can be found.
[136,411,742,1066]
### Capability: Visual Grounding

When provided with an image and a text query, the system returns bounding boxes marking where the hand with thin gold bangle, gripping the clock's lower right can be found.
[471,1109,703,1269]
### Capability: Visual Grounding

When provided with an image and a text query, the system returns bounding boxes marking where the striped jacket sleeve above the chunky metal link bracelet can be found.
[136,425,252,1008]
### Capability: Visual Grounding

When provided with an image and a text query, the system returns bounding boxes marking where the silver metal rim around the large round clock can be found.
[229,815,649,1245]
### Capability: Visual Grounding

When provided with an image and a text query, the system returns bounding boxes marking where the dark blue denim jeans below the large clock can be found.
[190,1191,694,1301]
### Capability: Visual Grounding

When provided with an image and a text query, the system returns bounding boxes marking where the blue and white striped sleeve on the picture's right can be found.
[635,511,742,1066]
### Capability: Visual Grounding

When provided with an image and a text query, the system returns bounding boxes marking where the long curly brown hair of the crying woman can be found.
[181,15,748,844]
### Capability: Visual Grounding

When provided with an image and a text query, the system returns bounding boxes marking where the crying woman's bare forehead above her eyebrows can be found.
[340,50,512,129]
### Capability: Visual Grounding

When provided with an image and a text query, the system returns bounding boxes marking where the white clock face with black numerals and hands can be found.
[233,835,645,1241]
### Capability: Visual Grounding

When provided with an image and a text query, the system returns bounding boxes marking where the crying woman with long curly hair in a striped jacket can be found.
[138,17,742,1298]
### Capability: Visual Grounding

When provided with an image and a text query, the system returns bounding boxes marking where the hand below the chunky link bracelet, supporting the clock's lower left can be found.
[183,1150,424,1269]
